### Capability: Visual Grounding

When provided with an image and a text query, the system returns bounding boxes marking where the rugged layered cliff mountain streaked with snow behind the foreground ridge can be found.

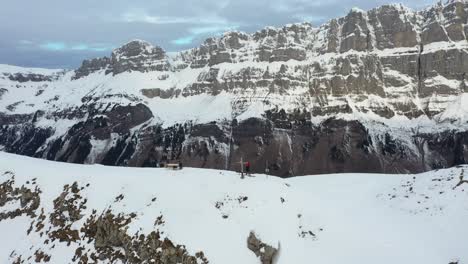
[0,1,468,176]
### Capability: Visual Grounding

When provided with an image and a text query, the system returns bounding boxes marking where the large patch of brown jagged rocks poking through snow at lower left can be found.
[0,172,209,264]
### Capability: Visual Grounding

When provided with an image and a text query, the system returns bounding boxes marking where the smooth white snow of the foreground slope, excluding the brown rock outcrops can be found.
[0,153,468,264]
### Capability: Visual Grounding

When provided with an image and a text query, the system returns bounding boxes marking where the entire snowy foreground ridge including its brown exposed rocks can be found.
[0,153,468,264]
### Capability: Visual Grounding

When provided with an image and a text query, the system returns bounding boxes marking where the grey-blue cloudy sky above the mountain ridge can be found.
[0,0,435,68]
